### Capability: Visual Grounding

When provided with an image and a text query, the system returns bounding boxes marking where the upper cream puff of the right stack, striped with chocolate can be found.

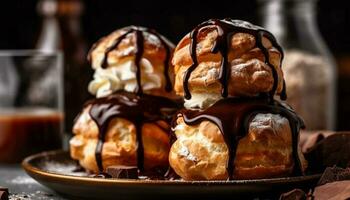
[172,20,284,108]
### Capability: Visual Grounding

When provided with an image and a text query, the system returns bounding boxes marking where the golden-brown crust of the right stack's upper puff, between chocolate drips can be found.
[172,26,283,96]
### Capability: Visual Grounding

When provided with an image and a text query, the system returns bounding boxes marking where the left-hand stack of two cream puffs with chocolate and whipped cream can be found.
[70,26,177,173]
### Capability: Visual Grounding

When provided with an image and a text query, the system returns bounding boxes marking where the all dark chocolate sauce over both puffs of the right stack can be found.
[172,19,305,179]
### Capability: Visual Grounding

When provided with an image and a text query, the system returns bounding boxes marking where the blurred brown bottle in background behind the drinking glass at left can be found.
[36,0,91,132]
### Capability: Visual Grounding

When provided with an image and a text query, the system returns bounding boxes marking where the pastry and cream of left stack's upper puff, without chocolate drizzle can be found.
[88,26,174,97]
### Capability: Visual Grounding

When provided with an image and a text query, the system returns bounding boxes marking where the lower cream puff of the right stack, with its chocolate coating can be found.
[169,98,307,180]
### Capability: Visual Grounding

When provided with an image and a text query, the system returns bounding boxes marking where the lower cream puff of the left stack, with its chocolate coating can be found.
[70,91,177,173]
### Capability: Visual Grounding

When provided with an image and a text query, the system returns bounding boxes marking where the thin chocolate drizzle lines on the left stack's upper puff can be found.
[88,26,172,94]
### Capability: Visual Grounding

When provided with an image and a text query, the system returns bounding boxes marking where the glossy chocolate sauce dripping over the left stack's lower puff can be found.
[86,91,178,172]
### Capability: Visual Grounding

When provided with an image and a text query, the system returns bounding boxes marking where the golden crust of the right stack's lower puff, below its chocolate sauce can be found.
[169,115,307,180]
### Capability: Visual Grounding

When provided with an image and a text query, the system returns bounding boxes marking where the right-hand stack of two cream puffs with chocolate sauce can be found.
[169,19,307,180]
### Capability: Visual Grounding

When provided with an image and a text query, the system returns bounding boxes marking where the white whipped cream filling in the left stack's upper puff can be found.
[88,58,165,98]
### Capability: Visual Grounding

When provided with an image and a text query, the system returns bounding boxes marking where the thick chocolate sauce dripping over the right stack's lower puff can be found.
[180,97,304,179]
